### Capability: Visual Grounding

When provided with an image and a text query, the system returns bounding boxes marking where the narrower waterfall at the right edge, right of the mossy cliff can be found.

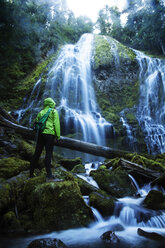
[135,51,165,154]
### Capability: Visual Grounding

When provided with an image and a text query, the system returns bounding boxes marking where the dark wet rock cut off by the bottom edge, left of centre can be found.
[27,238,67,248]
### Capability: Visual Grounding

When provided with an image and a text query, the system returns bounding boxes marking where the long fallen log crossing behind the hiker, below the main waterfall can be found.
[0,115,128,158]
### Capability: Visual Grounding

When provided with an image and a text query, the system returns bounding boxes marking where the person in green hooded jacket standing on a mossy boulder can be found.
[30,97,60,180]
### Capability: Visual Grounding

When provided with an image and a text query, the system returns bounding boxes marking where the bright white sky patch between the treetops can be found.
[67,0,127,22]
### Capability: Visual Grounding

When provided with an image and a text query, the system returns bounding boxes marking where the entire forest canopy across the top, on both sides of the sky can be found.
[0,0,165,104]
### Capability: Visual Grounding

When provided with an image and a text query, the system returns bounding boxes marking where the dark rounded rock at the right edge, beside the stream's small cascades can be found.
[143,190,165,210]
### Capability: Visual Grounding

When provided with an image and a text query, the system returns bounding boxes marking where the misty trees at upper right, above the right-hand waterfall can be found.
[97,0,165,54]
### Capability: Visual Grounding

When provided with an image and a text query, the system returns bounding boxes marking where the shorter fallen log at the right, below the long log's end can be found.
[120,158,163,179]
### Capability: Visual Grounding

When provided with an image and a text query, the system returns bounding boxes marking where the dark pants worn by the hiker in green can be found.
[30,133,54,177]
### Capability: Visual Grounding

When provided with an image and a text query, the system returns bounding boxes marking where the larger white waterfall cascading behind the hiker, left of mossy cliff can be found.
[16,34,112,161]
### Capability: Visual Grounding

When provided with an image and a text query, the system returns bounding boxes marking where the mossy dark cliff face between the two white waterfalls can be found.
[93,35,146,151]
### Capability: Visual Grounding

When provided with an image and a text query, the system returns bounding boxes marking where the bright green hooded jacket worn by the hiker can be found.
[35,97,60,139]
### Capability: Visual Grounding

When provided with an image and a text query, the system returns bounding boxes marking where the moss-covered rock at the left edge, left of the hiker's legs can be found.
[0,157,30,179]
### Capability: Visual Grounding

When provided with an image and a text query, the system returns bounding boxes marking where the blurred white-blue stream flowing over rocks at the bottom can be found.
[1,162,165,248]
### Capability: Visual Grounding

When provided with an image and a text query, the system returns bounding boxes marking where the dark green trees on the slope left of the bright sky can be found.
[0,0,93,107]
